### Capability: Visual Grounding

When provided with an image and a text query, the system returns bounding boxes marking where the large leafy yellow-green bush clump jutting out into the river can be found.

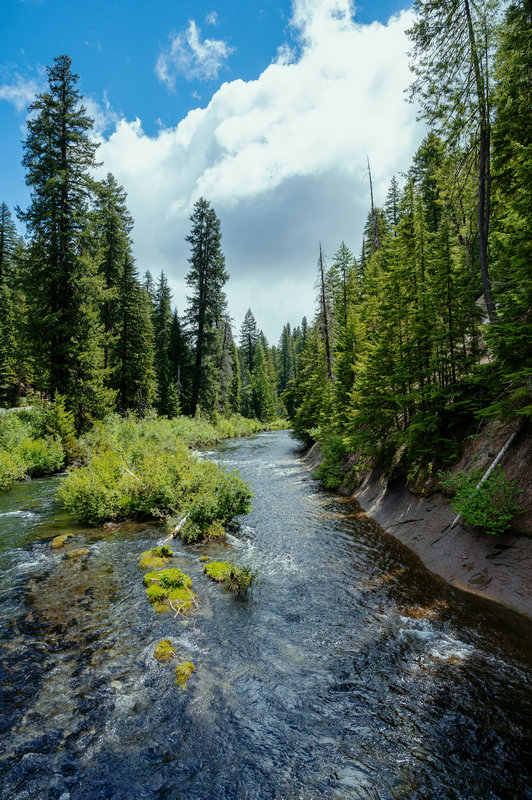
[58,416,251,541]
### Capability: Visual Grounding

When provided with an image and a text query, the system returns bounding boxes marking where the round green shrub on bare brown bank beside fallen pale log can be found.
[442,466,522,534]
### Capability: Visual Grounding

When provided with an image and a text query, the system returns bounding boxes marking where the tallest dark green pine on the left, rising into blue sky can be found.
[20,56,112,425]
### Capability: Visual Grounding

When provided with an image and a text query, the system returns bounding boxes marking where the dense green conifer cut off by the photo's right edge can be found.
[489,2,532,406]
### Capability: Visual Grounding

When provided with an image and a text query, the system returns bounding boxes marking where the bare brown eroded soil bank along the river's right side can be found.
[307,421,532,619]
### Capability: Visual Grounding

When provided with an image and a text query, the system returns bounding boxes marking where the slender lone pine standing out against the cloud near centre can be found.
[186,198,229,414]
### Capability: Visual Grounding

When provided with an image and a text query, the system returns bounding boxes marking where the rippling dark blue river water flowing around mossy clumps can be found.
[0,431,532,800]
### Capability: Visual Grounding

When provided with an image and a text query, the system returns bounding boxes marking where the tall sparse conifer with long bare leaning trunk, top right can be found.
[408,0,496,321]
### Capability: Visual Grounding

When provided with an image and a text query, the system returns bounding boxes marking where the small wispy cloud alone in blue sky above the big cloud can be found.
[155,20,233,88]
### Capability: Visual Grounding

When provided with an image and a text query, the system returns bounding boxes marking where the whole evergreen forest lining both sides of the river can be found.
[0,0,532,494]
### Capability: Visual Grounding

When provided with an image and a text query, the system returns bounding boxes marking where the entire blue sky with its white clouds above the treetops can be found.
[0,0,421,342]
